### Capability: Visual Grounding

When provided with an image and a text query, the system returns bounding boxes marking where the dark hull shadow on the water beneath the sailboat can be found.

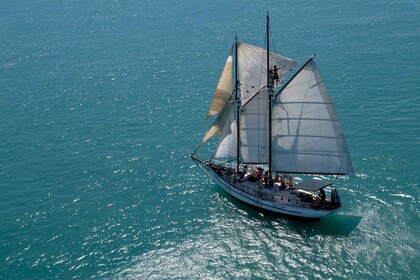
[219,190,362,237]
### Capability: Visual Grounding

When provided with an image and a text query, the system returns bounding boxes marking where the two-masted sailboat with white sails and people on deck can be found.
[191,15,354,218]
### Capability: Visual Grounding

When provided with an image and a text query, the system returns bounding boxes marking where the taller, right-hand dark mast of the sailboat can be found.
[266,12,274,179]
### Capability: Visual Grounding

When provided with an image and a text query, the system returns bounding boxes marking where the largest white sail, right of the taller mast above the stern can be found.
[272,59,353,174]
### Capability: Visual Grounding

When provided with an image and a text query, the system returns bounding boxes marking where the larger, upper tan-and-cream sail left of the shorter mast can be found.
[207,51,232,118]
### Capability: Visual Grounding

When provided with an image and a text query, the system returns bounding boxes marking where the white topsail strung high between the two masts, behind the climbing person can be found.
[238,43,297,104]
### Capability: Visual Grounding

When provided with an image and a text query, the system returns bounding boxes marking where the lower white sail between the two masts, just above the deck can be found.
[239,89,269,163]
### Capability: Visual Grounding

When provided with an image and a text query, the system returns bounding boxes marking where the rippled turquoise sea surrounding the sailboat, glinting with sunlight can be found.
[0,0,420,279]
